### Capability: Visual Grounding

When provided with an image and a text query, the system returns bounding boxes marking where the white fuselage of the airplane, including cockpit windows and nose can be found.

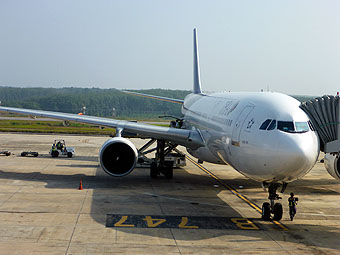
[182,92,320,182]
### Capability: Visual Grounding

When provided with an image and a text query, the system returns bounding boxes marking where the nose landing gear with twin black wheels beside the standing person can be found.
[262,183,287,220]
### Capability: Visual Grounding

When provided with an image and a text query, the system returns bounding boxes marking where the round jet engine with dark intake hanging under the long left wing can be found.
[99,137,138,177]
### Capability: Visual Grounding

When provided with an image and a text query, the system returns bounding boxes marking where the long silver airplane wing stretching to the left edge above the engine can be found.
[0,106,203,149]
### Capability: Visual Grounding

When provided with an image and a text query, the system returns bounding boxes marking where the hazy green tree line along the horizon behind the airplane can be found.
[0,87,313,119]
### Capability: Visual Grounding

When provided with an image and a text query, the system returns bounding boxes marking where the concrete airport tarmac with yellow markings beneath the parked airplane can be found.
[0,133,340,254]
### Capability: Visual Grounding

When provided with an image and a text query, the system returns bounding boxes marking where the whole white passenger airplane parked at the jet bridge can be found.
[0,29,340,220]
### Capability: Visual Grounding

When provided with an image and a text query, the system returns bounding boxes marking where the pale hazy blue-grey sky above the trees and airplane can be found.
[0,0,340,95]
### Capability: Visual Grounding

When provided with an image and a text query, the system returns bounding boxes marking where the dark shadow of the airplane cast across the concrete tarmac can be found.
[0,157,340,249]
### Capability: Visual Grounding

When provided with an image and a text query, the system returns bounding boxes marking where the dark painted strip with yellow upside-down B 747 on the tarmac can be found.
[106,214,261,230]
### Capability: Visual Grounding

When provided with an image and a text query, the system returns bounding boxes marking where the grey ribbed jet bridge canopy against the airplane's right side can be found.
[300,95,340,153]
